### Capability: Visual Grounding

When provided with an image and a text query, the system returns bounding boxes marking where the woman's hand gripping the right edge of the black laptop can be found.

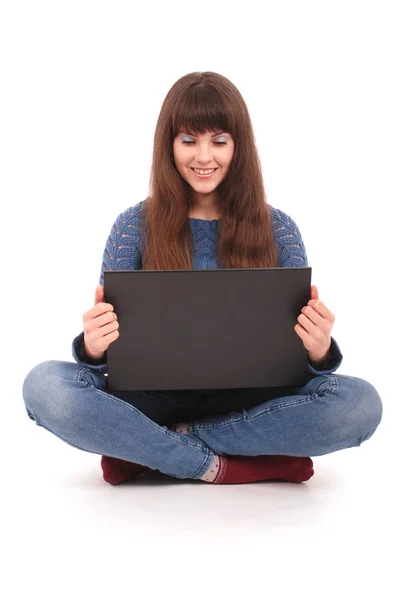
[294,285,335,362]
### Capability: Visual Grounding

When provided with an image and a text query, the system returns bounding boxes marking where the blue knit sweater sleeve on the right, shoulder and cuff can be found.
[272,208,343,375]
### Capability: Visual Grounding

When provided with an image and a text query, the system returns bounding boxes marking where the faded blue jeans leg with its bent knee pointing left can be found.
[23,361,213,479]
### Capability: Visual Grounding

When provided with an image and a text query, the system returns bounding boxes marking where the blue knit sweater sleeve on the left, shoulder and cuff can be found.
[72,202,143,375]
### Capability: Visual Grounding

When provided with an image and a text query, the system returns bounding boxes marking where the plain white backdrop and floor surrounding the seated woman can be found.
[0,0,401,599]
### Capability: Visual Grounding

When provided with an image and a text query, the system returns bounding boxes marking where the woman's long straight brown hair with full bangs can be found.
[142,71,277,270]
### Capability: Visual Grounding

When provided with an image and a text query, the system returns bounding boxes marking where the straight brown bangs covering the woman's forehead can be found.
[171,84,235,138]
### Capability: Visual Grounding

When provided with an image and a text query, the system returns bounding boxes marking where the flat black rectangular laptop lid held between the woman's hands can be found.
[104,267,311,391]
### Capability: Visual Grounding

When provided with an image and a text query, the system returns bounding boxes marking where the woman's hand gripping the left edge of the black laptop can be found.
[82,285,119,359]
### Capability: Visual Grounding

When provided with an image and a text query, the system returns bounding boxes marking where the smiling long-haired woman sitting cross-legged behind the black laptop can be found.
[23,72,382,484]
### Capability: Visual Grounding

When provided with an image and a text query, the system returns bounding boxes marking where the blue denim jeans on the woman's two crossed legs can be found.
[23,361,382,479]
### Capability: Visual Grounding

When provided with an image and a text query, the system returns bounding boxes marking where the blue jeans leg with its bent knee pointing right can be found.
[183,373,382,456]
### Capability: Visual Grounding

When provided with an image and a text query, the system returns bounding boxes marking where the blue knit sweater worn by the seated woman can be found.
[72,201,343,375]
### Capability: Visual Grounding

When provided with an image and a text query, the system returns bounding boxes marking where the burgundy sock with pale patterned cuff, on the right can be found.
[201,455,314,483]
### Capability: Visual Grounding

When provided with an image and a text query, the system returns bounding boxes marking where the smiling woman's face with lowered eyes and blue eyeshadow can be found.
[173,131,234,195]
